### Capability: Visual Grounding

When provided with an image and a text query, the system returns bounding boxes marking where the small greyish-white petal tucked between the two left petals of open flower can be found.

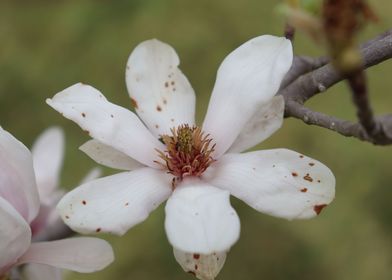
[79,139,143,170]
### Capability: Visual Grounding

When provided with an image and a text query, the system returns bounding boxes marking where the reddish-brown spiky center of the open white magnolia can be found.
[157,124,215,184]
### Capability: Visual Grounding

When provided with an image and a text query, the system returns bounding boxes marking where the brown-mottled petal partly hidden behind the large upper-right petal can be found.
[229,96,284,153]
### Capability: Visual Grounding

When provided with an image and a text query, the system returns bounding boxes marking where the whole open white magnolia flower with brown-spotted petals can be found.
[47,35,335,279]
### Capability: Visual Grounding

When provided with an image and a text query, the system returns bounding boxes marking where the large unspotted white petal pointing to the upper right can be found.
[203,35,293,158]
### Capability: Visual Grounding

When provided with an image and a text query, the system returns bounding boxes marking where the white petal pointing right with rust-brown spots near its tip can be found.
[204,149,335,220]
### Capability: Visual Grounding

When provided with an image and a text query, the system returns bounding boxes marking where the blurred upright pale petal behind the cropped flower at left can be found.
[31,127,64,203]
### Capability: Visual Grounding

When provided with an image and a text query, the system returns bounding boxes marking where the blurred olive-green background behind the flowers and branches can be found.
[0,0,392,280]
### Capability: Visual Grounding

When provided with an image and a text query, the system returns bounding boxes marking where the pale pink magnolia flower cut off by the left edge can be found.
[0,128,113,280]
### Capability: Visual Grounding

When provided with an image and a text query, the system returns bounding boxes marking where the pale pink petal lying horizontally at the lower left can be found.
[18,237,114,273]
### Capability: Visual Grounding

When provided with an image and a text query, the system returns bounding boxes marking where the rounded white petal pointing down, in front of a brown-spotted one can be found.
[165,181,240,255]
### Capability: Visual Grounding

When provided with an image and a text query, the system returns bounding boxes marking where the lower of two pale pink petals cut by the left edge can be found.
[0,197,31,275]
